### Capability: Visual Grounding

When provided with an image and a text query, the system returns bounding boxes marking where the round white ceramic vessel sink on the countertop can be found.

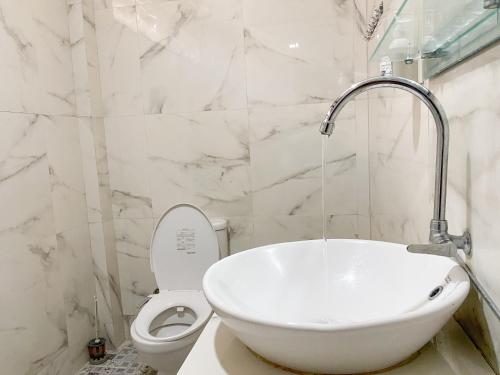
[203,240,469,374]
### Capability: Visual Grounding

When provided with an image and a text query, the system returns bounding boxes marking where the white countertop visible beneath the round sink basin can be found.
[177,316,494,375]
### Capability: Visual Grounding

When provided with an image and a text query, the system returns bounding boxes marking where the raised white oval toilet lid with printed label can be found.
[151,204,219,290]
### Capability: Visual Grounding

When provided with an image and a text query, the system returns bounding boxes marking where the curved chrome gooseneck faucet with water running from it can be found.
[320,76,472,257]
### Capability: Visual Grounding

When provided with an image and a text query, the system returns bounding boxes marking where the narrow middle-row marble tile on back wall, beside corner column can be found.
[104,116,152,218]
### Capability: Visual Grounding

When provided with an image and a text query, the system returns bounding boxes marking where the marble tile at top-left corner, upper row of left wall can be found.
[0,0,74,114]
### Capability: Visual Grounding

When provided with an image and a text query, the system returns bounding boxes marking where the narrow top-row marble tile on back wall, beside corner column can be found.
[96,6,142,116]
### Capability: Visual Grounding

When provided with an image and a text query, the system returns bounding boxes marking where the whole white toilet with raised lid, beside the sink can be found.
[130,204,228,375]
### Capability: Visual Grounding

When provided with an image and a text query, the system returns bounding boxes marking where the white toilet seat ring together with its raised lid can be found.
[134,204,219,345]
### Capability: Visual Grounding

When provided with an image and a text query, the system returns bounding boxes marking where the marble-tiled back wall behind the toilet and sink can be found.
[96,0,369,315]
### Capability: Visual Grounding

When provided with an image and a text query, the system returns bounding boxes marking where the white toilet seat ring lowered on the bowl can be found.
[134,290,212,343]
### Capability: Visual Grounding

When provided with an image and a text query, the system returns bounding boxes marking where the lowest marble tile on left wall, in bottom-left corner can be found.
[0,238,67,374]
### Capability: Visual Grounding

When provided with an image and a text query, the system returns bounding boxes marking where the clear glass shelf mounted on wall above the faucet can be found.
[370,0,500,79]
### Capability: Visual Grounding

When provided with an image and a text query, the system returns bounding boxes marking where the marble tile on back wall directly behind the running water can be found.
[249,104,357,216]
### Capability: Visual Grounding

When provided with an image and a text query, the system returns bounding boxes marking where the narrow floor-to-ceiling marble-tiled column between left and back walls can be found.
[68,0,126,347]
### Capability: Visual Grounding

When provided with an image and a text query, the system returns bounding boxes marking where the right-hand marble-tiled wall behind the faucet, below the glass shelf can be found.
[368,0,500,372]
